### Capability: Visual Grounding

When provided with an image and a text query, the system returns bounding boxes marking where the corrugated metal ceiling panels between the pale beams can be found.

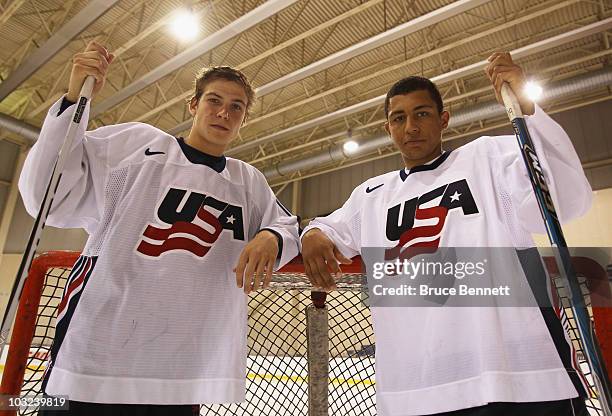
[0,0,612,185]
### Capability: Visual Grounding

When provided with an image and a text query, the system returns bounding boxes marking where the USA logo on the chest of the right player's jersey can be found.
[385,179,478,260]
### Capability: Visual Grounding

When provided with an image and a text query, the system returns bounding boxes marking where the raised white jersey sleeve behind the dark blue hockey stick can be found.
[494,106,593,233]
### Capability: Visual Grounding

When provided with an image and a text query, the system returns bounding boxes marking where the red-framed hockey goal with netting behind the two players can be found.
[0,252,612,416]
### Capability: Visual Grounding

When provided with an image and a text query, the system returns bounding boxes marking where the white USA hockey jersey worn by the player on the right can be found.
[304,108,592,416]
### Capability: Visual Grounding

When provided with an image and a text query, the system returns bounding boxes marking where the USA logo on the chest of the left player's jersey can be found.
[136,188,244,257]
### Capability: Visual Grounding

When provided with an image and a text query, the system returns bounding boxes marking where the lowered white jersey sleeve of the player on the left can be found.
[254,171,299,270]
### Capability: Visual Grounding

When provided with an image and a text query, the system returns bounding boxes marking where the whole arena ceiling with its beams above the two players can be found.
[0,0,612,190]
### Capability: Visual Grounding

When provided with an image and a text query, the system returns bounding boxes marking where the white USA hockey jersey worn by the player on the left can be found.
[19,96,298,404]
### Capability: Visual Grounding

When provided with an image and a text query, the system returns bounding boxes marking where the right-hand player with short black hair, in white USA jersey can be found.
[302,53,592,416]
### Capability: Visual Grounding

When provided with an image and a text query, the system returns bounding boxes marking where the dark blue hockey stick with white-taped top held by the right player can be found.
[501,83,612,416]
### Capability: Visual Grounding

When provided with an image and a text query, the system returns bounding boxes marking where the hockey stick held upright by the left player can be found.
[0,76,95,352]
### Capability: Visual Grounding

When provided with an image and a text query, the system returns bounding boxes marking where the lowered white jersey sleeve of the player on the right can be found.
[302,186,363,259]
